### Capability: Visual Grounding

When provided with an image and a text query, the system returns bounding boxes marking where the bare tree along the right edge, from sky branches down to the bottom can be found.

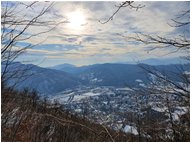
[102,2,190,141]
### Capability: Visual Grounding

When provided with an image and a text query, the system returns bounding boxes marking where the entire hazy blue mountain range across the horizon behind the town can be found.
[2,63,190,94]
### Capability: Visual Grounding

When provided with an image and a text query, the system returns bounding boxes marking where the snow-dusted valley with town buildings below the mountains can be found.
[49,86,189,135]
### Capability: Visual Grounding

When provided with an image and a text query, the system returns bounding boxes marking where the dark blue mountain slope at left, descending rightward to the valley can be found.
[1,63,81,94]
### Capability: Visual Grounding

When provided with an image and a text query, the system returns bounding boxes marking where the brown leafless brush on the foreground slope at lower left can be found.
[1,86,135,142]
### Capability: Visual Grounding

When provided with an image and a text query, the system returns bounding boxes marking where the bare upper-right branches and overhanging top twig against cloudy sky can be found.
[101,1,190,49]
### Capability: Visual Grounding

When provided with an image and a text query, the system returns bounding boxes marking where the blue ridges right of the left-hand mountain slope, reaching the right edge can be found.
[50,63,190,87]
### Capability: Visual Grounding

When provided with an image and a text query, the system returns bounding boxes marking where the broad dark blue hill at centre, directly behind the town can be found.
[79,64,147,87]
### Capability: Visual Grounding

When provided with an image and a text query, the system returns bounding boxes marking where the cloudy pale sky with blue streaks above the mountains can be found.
[1,1,190,67]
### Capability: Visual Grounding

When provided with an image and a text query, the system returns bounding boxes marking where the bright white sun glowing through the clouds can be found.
[67,11,86,30]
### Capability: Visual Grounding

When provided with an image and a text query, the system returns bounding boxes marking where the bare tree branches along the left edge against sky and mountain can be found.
[1,2,62,85]
